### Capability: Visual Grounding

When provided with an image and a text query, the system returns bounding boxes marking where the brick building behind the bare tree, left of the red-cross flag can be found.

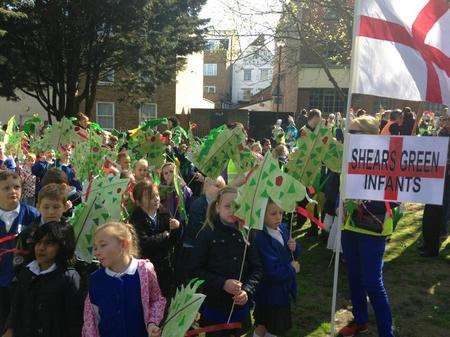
[273,4,443,114]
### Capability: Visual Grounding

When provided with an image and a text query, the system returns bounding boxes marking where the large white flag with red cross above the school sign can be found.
[353,0,450,105]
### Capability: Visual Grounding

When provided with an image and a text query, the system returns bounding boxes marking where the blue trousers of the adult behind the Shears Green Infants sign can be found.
[342,231,394,337]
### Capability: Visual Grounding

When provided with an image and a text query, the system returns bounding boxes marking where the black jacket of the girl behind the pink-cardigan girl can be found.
[130,207,181,297]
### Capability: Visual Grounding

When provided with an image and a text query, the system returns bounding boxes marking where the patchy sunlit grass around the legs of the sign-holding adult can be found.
[285,205,450,337]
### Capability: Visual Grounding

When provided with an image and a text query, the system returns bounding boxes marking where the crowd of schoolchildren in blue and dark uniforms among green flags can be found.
[0,109,448,337]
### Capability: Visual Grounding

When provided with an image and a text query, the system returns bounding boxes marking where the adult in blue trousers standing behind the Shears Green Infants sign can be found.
[339,116,394,337]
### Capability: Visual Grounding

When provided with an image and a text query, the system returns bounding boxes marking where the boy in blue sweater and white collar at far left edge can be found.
[0,171,39,330]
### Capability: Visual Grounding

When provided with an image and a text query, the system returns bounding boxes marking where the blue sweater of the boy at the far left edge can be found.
[0,203,41,287]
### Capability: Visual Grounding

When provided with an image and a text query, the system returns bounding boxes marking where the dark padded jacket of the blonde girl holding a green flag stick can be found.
[189,220,263,313]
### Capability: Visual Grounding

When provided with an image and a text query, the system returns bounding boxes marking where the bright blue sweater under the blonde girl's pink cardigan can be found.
[89,268,148,337]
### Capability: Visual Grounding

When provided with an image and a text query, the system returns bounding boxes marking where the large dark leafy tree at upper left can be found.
[0,0,206,120]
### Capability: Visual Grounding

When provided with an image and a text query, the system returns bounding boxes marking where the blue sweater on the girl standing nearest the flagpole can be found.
[254,224,300,307]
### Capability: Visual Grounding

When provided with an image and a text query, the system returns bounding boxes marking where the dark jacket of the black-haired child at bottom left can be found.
[7,268,82,337]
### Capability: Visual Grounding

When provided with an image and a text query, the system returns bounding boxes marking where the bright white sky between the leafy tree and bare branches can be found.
[201,0,282,48]
